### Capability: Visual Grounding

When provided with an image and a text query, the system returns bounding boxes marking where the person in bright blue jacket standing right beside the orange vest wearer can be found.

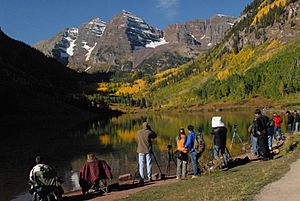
[184,125,198,179]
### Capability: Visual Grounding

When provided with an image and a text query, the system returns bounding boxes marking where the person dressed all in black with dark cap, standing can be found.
[254,109,271,161]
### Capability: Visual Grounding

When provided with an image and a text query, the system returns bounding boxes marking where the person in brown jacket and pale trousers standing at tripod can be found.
[137,122,157,184]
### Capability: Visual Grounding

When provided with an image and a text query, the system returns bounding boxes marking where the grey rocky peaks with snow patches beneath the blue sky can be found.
[34,11,236,73]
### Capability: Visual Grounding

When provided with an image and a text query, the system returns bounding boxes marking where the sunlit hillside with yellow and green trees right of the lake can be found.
[140,0,300,108]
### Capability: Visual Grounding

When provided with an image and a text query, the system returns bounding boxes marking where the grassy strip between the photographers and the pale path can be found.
[122,135,300,201]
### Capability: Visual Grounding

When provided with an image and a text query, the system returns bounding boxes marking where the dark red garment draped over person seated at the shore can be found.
[80,160,112,184]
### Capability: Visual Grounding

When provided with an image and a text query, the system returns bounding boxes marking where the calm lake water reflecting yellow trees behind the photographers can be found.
[0,111,264,200]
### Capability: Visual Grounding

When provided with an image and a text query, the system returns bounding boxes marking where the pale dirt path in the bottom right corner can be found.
[254,159,300,201]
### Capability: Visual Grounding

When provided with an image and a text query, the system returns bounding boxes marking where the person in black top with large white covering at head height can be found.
[211,117,228,167]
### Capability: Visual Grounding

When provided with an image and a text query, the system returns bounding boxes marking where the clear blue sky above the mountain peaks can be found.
[0,0,252,44]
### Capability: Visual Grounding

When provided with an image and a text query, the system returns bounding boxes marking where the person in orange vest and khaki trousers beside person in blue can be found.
[176,128,188,179]
